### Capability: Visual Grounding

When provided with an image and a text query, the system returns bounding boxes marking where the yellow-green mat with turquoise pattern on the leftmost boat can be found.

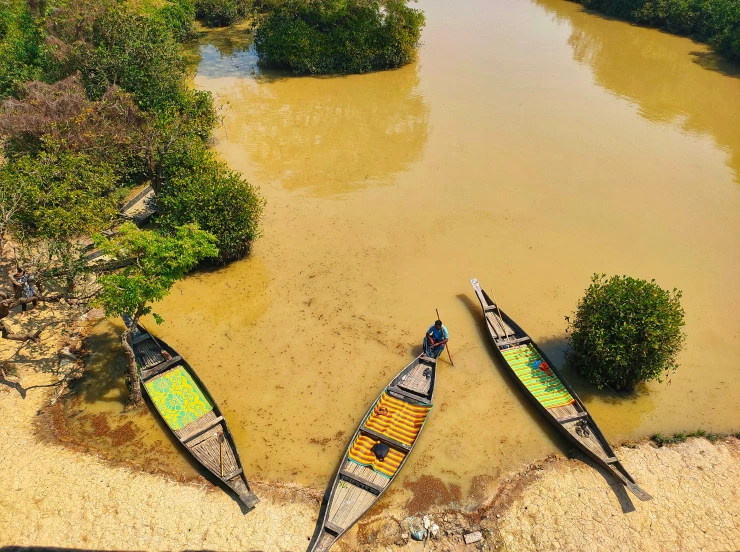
[145,366,213,430]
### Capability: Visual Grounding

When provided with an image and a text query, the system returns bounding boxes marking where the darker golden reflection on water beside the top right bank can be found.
[534,0,740,183]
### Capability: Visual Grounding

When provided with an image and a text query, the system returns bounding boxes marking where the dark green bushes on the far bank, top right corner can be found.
[575,0,740,61]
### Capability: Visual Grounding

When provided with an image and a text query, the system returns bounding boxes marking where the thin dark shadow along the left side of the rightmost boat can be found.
[457,294,635,514]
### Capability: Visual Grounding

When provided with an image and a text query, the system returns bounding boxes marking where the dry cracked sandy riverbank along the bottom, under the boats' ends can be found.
[0,364,740,552]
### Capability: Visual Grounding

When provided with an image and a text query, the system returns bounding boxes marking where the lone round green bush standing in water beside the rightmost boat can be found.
[566,274,684,391]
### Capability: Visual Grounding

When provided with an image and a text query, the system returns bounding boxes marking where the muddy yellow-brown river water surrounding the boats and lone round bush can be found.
[65,0,740,508]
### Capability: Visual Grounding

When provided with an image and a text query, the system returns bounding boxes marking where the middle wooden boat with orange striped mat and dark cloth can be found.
[308,355,437,552]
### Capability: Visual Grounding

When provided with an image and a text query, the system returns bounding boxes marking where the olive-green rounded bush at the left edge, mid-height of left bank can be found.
[0,151,122,239]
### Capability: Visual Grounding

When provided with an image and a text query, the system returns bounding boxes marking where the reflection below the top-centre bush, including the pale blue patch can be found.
[196,35,429,196]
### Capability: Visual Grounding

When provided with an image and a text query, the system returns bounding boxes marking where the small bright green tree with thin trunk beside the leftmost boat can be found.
[95,223,218,406]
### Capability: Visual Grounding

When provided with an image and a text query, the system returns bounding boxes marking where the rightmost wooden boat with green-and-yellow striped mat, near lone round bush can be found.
[470,278,652,500]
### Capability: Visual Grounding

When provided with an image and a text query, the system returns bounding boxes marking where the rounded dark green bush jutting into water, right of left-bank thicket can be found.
[157,147,264,262]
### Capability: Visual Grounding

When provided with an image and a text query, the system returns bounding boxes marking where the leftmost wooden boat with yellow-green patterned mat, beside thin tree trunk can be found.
[124,319,259,509]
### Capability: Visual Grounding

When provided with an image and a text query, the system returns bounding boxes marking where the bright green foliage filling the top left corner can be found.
[0,0,50,98]
